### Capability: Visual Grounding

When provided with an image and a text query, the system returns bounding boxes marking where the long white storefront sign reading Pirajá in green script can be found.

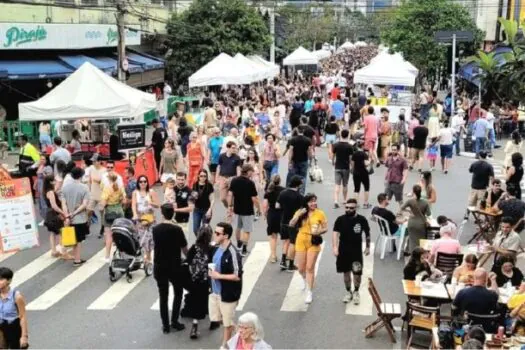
[0,23,141,50]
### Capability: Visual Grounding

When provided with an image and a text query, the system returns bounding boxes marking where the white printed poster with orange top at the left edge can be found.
[0,178,39,253]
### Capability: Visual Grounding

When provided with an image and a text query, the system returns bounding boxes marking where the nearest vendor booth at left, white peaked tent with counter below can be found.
[18,62,157,183]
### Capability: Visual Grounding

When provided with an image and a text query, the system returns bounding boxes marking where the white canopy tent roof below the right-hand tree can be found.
[354,62,416,86]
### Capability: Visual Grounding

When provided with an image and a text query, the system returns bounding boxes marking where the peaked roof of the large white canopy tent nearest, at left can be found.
[18,62,157,121]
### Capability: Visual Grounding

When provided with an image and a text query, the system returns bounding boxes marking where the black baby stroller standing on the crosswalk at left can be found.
[109,218,153,283]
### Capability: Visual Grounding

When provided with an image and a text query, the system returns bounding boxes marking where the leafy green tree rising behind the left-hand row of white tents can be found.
[167,0,271,84]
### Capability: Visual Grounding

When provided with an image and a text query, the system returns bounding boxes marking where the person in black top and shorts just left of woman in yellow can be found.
[275,175,304,272]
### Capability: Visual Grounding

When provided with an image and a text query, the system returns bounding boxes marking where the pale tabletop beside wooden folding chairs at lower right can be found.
[402,280,517,304]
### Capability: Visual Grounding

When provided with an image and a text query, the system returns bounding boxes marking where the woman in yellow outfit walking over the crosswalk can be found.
[290,193,328,304]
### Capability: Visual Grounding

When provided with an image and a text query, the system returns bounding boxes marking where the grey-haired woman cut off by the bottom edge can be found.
[227,312,272,350]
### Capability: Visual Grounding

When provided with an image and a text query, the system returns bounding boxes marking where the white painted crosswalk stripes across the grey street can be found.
[0,241,384,315]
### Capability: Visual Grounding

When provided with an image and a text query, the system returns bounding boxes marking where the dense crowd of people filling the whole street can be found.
[0,46,525,349]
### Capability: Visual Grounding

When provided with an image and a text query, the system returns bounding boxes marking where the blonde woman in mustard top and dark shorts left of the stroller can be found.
[100,173,126,262]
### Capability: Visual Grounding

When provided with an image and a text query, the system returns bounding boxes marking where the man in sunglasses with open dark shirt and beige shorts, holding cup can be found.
[208,222,242,349]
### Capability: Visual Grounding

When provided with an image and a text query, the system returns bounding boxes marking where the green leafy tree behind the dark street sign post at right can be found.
[381,0,484,83]
